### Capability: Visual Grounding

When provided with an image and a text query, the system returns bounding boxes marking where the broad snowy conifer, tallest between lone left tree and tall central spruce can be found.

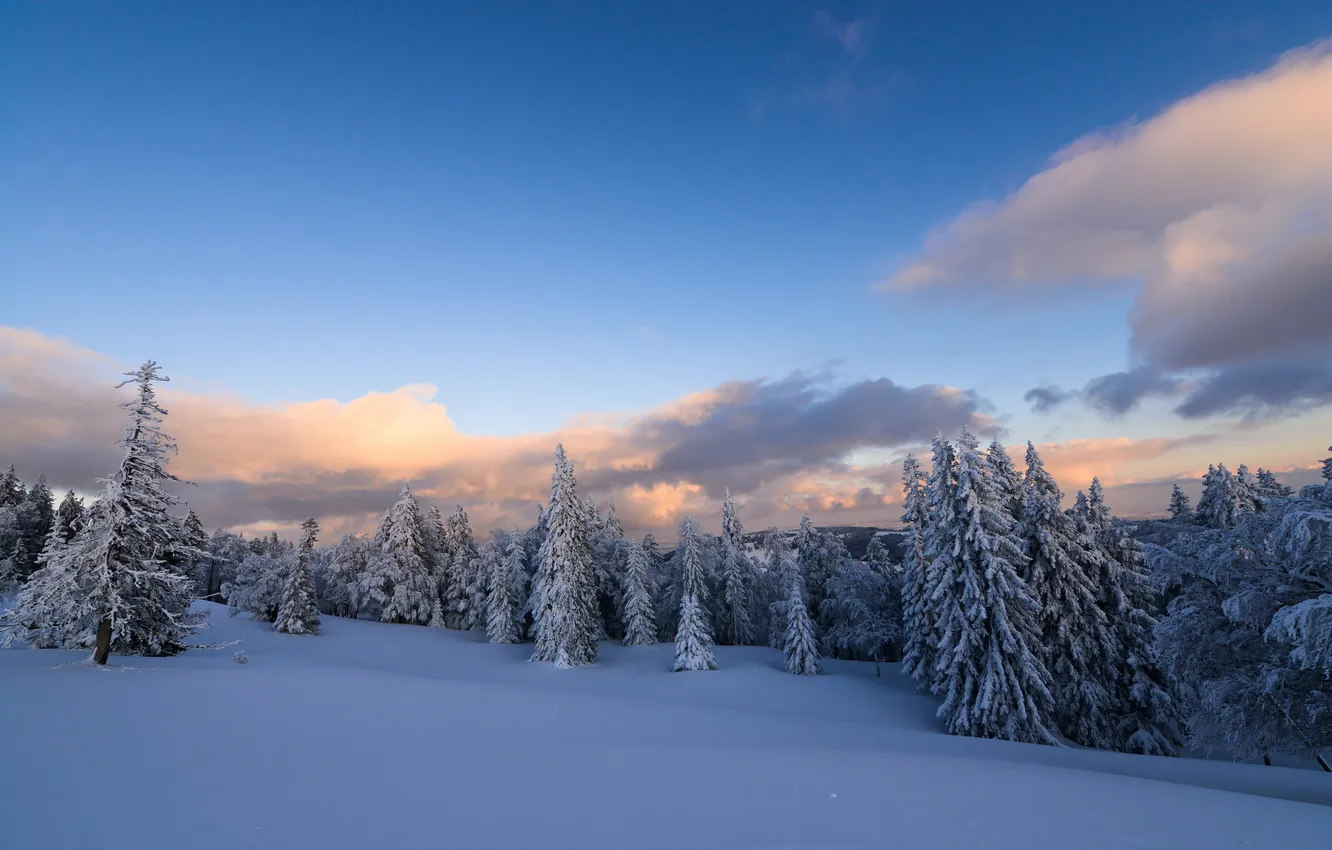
[360,485,437,625]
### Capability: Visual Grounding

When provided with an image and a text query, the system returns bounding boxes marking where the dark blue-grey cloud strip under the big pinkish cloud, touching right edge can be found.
[1175,362,1332,421]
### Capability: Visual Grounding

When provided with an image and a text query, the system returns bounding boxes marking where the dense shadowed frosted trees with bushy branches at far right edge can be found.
[1140,448,1332,770]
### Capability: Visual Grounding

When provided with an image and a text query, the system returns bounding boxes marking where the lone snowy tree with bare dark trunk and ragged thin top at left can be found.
[0,360,200,665]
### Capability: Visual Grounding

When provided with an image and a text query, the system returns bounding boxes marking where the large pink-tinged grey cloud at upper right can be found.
[886,43,1332,423]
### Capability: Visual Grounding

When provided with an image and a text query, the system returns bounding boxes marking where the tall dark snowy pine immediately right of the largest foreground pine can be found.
[1020,442,1115,747]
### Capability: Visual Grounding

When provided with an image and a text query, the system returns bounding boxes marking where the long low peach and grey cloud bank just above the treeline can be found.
[0,328,994,536]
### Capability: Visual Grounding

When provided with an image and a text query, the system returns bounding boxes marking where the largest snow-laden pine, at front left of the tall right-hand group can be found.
[931,432,1054,743]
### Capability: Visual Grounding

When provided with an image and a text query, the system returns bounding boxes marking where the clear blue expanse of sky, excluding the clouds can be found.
[0,1,1332,535]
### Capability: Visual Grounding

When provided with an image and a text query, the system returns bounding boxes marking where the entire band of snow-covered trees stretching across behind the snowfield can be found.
[0,361,1332,769]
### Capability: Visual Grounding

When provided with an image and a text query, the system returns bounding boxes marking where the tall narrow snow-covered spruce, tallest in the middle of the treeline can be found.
[531,445,601,667]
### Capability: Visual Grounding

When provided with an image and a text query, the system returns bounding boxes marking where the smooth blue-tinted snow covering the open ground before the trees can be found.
[0,605,1332,850]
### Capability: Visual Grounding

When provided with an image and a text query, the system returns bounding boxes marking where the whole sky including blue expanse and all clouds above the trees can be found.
[0,0,1332,537]
